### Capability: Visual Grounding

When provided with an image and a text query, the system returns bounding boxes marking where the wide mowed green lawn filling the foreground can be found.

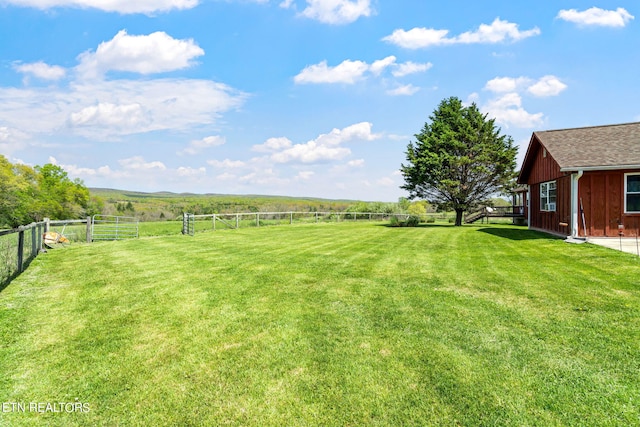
[0,223,640,426]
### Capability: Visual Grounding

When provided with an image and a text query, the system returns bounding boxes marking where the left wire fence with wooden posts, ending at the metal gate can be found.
[0,215,138,289]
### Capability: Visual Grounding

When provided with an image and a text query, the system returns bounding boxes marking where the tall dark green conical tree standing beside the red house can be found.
[401,97,518,225]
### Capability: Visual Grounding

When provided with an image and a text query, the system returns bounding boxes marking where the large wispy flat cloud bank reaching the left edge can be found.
[0,79,246,140]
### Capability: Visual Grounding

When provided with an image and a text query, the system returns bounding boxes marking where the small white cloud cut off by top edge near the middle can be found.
[302,0,373,24]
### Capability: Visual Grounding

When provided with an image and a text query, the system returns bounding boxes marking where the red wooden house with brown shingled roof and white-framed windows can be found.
[518,122,640,237]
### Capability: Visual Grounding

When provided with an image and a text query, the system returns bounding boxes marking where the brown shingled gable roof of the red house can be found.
[520,122,640,182]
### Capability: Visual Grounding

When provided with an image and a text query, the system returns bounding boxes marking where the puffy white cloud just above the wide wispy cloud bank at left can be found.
[77,30,204,78]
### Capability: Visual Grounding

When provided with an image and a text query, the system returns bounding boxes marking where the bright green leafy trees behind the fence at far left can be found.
[0,155,102,228]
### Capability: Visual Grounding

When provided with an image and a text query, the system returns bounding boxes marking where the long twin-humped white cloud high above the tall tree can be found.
[382,18,540,49]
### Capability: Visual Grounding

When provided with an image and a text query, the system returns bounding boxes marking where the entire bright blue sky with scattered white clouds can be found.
[0,0,640,201]
